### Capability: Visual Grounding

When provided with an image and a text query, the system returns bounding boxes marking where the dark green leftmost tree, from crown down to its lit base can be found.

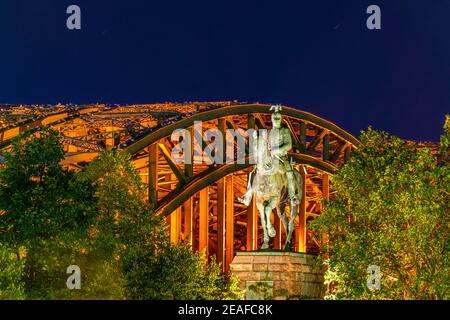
[0,128,96,298]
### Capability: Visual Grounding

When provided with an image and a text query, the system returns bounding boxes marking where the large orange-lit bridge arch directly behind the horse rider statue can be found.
[119,104,359,269]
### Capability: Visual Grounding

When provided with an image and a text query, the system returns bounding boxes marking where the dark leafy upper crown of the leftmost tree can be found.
[0,128,93,246]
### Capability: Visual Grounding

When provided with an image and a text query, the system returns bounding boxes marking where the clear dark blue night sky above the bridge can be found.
[0,0,450,140]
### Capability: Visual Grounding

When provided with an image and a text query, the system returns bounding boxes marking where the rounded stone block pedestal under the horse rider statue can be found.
[230,251,325,300]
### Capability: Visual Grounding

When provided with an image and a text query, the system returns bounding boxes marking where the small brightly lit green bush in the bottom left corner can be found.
[0,243,25,300]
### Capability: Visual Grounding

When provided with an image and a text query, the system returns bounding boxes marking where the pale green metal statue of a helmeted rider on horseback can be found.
[238,105,303,251]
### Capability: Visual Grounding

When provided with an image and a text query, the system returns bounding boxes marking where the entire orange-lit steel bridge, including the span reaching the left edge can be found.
[0,102,359,270]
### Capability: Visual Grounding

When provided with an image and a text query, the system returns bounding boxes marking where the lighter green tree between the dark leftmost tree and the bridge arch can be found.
[74,150,166,299]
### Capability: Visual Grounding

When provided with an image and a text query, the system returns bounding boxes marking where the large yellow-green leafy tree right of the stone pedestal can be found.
[311,117,450,299]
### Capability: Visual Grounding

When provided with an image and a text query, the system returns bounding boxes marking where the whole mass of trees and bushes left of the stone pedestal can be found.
[0,132,243,299]
